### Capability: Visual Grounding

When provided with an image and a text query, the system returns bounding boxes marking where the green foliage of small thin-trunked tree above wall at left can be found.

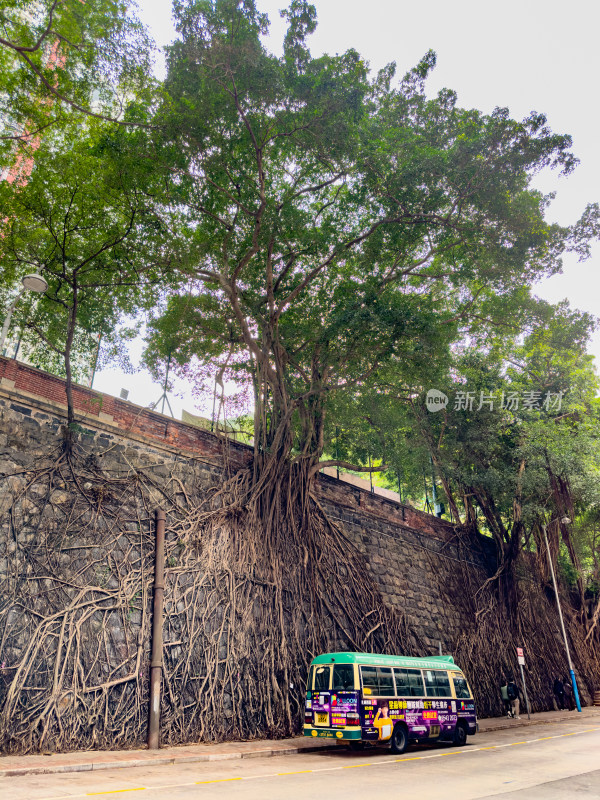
[0,123,169,400]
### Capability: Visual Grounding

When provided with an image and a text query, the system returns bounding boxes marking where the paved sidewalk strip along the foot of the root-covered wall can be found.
[0,706,600,778]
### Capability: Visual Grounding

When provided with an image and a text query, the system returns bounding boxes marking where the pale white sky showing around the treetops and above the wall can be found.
[94,0,600,417]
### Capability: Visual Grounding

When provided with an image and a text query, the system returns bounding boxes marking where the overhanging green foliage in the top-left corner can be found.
[0,0,155,169]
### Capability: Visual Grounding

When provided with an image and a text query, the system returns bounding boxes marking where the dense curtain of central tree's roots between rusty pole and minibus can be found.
[163,456,418,742]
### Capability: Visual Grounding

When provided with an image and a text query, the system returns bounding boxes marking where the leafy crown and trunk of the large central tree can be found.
[149,0,595,517]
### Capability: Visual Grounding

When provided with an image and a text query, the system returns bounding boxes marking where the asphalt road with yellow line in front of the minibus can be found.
[0,719,600,800]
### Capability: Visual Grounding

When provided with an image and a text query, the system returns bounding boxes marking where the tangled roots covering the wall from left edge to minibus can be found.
[0,448,419,752]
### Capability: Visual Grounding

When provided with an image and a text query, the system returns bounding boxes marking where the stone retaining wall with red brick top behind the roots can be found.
[0,358,586,751]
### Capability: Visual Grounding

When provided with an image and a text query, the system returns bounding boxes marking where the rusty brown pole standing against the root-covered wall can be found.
[148,508,166,750]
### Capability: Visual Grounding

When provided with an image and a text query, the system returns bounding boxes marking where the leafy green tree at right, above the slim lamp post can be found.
[353,301,599,612]
